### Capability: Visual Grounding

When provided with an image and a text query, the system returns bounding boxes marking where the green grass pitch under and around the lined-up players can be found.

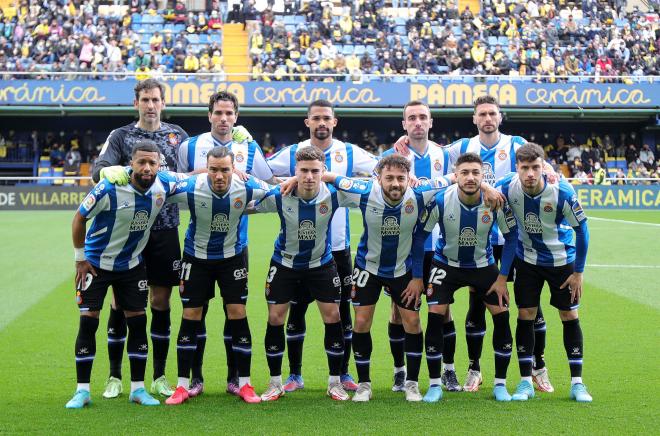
[0,211,660,434]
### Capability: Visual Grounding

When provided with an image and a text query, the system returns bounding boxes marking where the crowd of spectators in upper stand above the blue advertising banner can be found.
[0,0,660,82]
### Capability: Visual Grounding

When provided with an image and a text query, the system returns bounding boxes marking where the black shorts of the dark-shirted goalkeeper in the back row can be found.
[142,229,181,287]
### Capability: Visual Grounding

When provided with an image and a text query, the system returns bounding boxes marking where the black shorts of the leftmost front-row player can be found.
[76,262,149,312]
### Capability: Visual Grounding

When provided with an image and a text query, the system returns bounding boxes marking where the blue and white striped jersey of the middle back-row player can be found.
[268,139,378,251]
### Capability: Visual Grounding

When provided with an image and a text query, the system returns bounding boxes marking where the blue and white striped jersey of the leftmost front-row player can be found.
[78,172,177,271]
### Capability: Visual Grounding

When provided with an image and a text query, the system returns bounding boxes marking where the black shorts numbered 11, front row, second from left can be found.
[179,253,248,307]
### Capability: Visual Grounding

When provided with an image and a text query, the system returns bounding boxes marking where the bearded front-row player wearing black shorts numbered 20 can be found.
[324,155,447,402]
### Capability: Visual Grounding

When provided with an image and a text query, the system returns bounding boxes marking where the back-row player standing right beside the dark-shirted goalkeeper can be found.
[178,91,279,397]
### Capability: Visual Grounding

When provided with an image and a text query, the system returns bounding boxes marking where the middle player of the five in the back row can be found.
[268,100,378,392]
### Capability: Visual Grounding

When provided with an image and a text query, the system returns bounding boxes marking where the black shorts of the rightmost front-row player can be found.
[513,257,579,310]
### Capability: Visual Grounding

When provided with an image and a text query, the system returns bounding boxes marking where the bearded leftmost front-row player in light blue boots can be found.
[66,141,175,409]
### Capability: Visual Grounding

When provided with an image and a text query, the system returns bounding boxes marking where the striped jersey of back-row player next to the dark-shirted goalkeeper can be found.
[178,132,273,251]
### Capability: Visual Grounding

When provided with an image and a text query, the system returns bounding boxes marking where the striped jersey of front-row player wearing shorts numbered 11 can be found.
[167,174,270,260]
